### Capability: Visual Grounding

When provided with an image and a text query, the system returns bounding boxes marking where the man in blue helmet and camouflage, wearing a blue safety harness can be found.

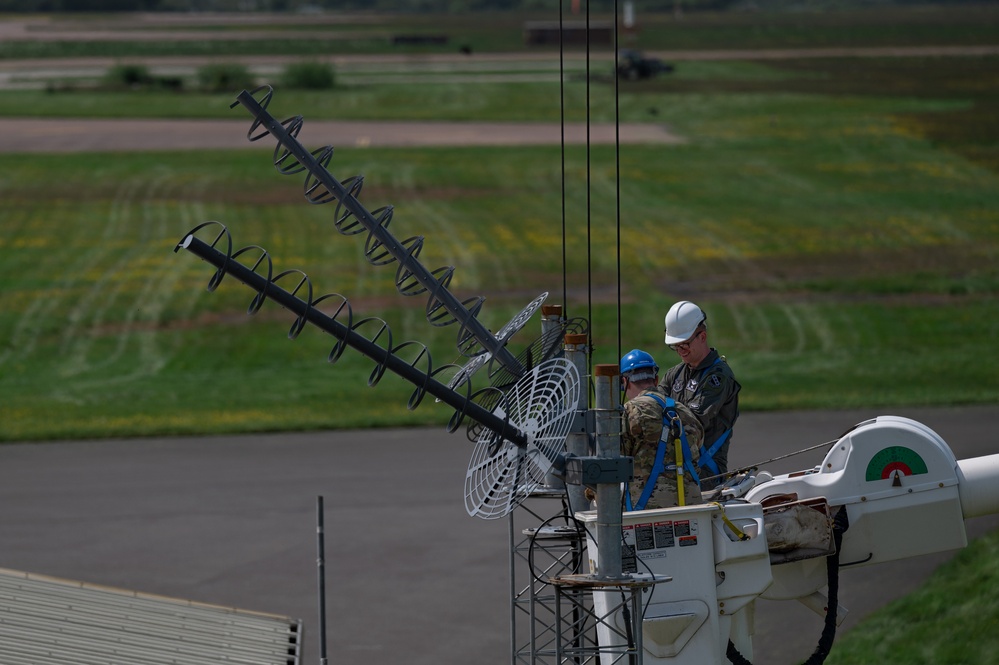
[621,349,703,510]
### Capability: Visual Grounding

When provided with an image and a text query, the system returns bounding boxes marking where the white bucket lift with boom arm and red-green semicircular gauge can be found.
[578,416,999,665]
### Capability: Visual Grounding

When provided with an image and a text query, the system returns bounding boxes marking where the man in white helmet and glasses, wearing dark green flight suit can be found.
[659,300,741,490]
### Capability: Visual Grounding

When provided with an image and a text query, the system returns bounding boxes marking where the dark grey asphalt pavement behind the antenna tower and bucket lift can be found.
[0,407,999,665]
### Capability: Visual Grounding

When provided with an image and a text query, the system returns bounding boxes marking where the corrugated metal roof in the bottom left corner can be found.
[0,568,302,665]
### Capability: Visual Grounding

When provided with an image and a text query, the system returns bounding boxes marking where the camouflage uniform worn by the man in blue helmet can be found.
[621,387,704,509]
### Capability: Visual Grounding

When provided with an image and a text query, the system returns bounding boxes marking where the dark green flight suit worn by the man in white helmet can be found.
[659,349,741,489]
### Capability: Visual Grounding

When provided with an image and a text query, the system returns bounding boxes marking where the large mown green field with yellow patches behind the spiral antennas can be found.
[0,5,999,440]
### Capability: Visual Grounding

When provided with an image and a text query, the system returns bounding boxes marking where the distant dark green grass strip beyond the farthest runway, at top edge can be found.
[0,3,999,59]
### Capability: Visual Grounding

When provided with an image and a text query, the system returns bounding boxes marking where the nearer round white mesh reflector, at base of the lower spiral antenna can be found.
[465,358,580,519]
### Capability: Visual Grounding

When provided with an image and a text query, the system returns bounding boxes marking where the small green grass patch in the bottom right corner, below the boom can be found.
[826,532,999,665]
